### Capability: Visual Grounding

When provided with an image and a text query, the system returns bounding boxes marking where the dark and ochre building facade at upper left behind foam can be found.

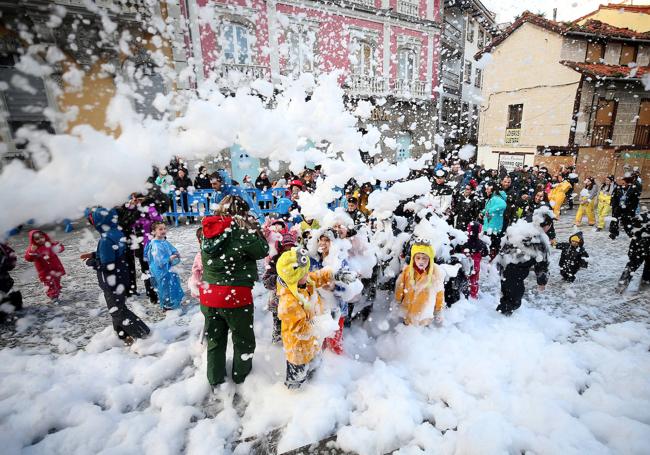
[0,0,190,164]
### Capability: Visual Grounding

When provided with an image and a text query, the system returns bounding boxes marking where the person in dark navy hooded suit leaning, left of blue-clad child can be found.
[86,207,150,340]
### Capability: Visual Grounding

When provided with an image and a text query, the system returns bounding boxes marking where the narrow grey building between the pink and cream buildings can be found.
[440,0,497,151]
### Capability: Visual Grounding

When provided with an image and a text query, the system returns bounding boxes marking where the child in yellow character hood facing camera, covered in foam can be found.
[395,242,445,325]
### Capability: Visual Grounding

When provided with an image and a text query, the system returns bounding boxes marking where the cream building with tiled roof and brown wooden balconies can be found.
[476,13,650,196]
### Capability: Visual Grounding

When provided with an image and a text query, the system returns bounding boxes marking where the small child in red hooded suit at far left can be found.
[25,229,65,300]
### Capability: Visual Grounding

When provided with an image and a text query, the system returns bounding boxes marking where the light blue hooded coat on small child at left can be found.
[144,239,185,308]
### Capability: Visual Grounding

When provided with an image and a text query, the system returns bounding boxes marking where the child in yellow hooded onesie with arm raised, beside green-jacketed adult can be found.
[276,248,334,389]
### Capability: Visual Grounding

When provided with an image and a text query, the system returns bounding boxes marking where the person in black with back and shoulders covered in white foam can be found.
[497,207,553,316]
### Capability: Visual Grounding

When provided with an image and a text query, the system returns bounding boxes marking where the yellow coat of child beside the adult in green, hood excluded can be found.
[277,269,333,365]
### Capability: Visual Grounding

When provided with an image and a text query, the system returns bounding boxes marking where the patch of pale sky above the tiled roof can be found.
[482,0,650,23]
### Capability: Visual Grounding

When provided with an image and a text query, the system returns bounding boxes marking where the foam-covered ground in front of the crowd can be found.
[0,215,650,454]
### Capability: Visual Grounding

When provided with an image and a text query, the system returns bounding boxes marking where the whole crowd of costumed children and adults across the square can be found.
[0,158,650,396]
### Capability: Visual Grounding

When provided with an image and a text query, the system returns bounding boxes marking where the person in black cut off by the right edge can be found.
[616,211,650,294]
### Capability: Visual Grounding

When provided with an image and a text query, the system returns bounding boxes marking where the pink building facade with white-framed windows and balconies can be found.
[186,0,441,177]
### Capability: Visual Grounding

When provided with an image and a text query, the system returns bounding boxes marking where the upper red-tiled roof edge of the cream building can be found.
[474,11,650,59]
